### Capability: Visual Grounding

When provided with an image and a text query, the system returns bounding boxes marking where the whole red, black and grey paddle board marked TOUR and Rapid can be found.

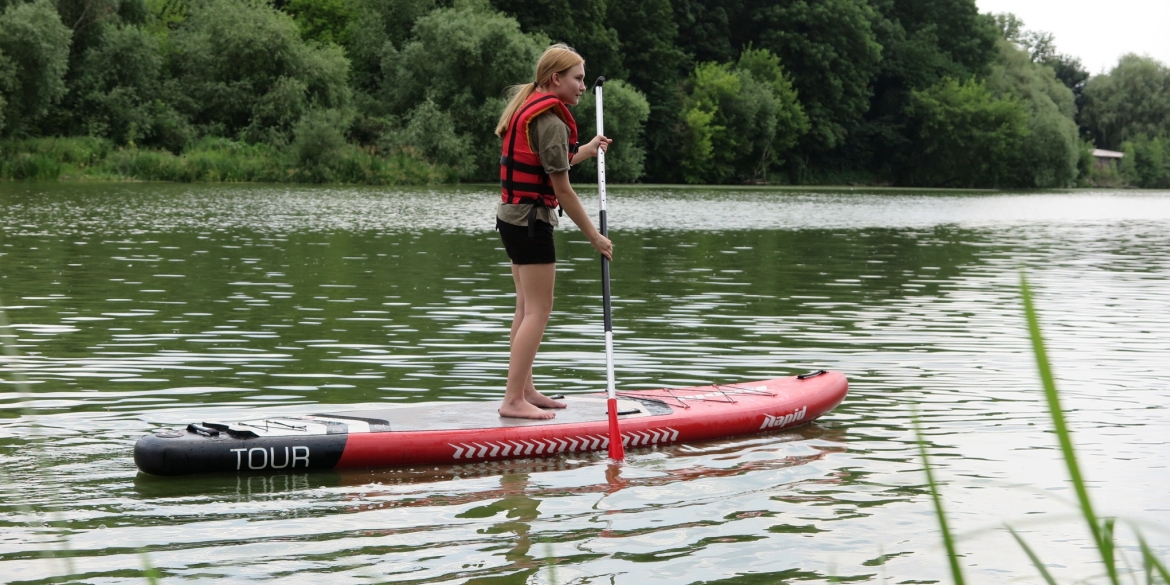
[135,371,848,475]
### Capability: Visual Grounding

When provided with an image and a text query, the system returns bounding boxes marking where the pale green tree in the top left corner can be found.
[0,0,71,136]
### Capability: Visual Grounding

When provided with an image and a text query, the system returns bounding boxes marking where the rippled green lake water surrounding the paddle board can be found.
[0,184,1170,585]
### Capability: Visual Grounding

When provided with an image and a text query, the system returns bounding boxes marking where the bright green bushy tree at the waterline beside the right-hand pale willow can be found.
[900,77,1028,187]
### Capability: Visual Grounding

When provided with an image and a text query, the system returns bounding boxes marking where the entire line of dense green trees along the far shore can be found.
[0,0,1170,188]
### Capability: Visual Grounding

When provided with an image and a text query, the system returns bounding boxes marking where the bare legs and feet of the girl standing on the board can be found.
[500,263,564,419]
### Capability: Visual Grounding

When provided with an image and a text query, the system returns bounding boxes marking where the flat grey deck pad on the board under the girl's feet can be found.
[314,395,654,432]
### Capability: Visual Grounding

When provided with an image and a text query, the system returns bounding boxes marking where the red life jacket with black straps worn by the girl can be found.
[500,91,577,209]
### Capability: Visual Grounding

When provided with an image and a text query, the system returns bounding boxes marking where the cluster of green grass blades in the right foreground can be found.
[914,273,1170,585]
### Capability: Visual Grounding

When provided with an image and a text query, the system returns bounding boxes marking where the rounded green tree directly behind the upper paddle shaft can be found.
[573,80,651,183]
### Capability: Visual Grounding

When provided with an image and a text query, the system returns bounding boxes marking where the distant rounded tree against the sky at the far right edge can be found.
[1080,54,1170,150]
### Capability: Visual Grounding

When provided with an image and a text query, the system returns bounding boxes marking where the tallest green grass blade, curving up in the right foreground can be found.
[1020,271,1120,585]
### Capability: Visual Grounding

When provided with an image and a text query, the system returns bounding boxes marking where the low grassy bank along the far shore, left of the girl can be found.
[0,137,456,185]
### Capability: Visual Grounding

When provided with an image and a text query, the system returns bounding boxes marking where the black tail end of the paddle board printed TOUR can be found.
[135,431,349,475]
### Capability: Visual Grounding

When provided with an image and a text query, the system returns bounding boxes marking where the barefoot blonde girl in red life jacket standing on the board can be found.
[496,44,613,419]
